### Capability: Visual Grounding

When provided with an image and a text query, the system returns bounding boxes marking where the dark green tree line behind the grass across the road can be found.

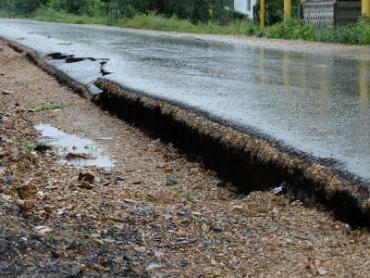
[0,0,240,23]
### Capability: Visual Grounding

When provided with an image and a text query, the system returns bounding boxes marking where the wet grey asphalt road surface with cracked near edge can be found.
[0,20,370,182]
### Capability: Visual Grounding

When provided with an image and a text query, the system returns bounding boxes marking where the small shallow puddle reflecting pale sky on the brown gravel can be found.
[35,124,114,168]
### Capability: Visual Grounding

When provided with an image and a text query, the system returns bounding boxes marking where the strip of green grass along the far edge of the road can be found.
[0,7,370,45]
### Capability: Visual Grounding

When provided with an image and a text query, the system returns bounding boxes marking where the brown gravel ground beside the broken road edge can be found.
[0,42,370,277]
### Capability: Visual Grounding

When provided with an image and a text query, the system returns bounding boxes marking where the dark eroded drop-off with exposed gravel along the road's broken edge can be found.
[2,35,370,227]
